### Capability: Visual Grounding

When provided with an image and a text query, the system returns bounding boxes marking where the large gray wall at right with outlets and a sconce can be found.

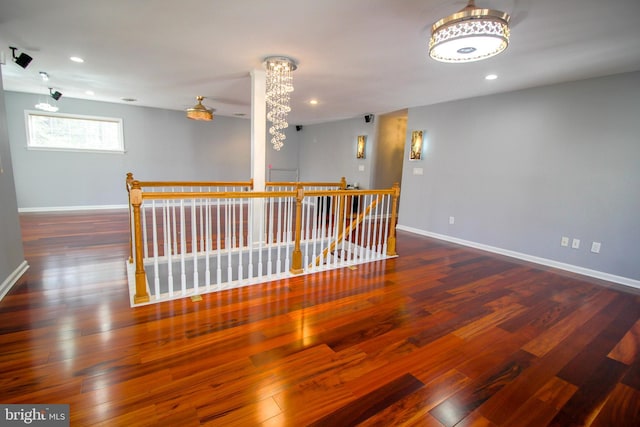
[399,72,640,280]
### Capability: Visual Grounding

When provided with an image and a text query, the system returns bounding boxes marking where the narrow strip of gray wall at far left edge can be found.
[0,70,26,295]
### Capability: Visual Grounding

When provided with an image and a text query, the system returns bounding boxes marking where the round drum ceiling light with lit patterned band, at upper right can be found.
[429,0,511,63]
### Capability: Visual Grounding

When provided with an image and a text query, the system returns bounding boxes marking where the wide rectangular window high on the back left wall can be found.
[25,111,124,153]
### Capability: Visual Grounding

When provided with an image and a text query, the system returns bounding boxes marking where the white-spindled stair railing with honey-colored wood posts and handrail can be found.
[127,175,399,304]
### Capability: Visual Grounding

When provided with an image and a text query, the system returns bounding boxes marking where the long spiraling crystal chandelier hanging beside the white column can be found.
[264,56,298,151]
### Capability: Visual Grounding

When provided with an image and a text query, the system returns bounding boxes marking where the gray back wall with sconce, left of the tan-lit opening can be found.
[298,116,376,188]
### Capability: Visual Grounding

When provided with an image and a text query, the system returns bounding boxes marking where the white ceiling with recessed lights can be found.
[0,0,640,124]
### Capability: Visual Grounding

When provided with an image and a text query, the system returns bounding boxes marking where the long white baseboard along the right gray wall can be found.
[396,224,640,289]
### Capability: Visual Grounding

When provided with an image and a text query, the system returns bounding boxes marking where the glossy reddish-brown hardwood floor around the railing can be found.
[0,211,640,427]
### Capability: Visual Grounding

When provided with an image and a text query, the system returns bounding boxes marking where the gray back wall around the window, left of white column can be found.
[5,92,251,209]
